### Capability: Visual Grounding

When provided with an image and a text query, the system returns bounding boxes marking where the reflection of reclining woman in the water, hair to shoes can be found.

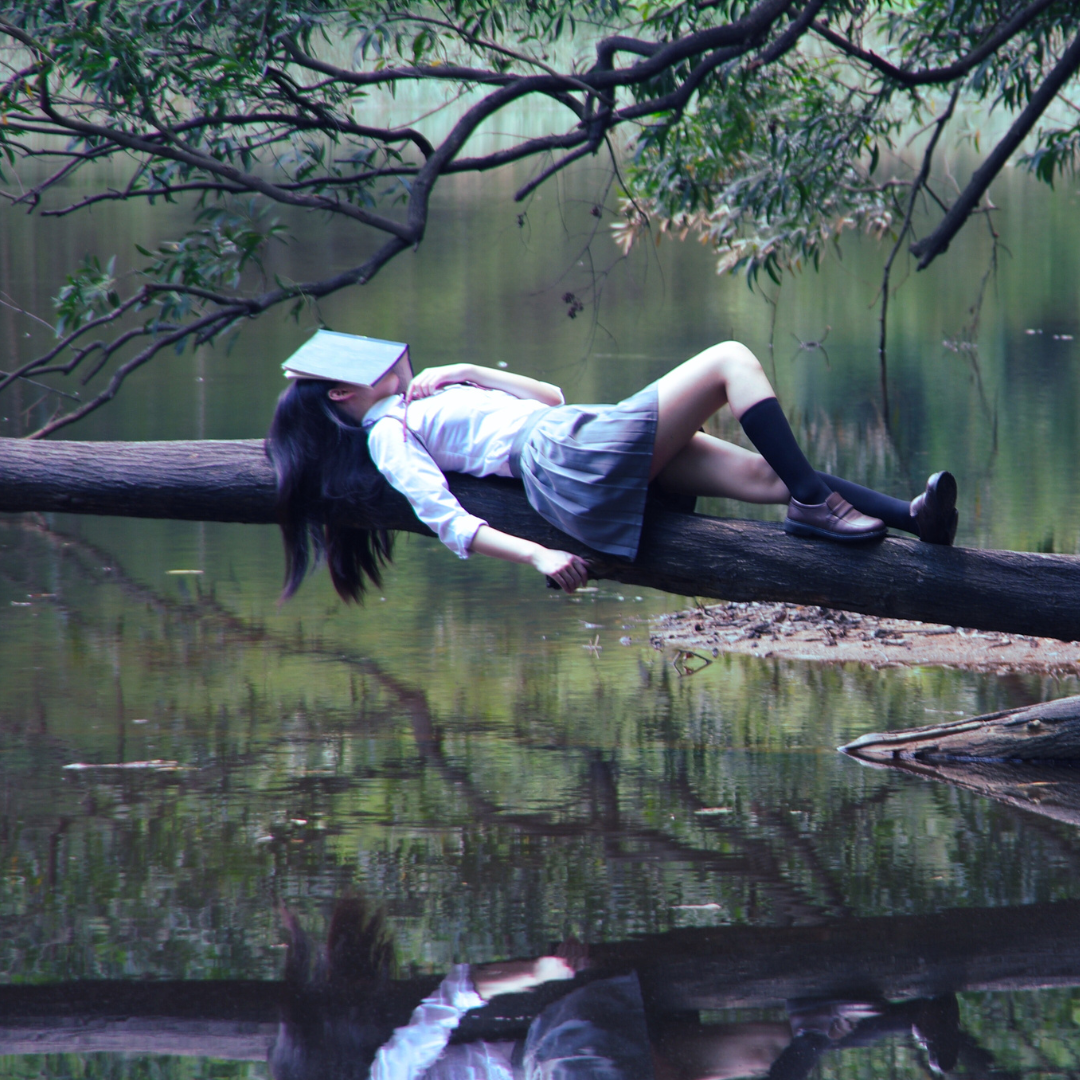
[270,899,959,1080]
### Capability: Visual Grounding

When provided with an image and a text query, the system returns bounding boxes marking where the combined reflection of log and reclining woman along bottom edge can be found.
[6,896,1080,1080]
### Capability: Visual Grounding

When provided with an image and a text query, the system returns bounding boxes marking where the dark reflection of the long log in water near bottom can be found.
[6,901,1080,1059]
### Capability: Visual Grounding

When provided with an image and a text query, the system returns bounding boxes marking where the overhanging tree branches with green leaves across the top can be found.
[0,0,1080,435]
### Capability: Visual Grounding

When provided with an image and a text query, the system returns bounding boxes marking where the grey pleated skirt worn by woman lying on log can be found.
[511,382,658,559]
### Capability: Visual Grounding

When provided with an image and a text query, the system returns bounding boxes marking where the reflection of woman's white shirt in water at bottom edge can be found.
[370,967,512,1080]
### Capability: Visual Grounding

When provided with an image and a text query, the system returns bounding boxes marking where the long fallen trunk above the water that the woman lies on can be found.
[0,438,1080,640]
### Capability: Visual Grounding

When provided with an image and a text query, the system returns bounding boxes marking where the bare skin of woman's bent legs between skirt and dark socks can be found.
[650,341,791,502]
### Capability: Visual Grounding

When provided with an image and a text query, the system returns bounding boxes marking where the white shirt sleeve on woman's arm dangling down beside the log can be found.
[367,417,487,558]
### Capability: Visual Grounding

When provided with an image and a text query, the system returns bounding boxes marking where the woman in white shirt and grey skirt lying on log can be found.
[267,341,957,599]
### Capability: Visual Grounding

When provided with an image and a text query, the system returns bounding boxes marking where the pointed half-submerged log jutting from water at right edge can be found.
[840,697,1080,773]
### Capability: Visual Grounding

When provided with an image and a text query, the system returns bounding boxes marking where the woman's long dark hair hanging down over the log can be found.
[266,379,394,602]
